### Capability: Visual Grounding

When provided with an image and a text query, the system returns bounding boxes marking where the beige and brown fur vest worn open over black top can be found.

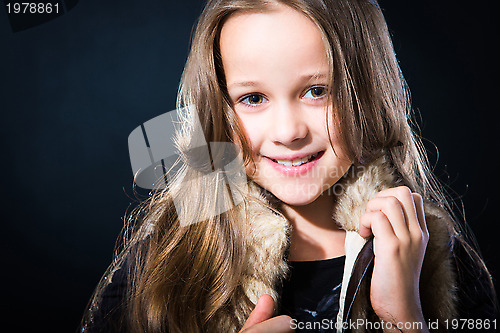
[234,158,456,332]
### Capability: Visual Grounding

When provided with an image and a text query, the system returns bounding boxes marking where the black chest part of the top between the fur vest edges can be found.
[281,256,345,332]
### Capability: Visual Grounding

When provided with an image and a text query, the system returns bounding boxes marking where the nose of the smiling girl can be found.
[269,102,309,145]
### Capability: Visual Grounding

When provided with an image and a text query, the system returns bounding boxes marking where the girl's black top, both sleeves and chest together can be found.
[82,237,500,333]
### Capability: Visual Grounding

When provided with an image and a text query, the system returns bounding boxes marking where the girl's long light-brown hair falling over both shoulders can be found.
[80,0,490,332]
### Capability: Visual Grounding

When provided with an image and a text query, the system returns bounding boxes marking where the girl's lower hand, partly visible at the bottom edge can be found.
[240,295,293,333]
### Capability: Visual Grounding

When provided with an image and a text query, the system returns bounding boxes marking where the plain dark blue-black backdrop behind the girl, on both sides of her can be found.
[0,0,500,332]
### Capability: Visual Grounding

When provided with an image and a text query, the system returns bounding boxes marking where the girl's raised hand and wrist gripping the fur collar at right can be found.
[359,186,429,332]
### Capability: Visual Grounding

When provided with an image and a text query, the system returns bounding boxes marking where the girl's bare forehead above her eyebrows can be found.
[220,4,328,82]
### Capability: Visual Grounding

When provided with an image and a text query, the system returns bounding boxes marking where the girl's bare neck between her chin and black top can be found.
[283,194,345,261]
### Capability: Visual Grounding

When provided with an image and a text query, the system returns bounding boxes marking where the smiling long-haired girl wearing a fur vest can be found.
[82,0,496,332]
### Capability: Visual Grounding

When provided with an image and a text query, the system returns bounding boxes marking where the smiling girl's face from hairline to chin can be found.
[220,5,351,206]
